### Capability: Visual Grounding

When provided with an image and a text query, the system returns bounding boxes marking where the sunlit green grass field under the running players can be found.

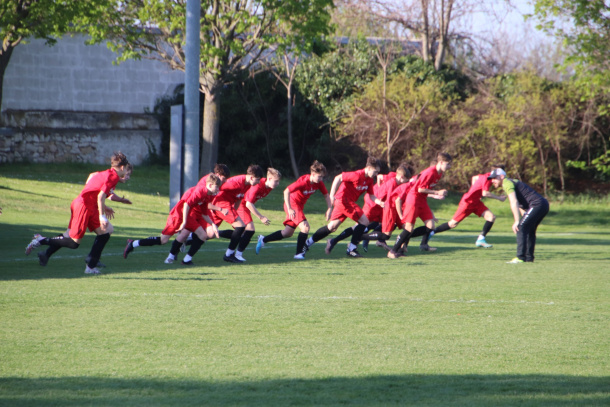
[0,164,610,406]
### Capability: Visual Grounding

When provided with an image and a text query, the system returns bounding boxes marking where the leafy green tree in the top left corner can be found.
[0,0,109,113]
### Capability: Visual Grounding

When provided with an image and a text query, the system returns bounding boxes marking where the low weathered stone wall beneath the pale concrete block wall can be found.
[0,110,161,165]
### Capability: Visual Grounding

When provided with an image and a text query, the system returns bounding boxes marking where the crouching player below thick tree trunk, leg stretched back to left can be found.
[123,174,221,265]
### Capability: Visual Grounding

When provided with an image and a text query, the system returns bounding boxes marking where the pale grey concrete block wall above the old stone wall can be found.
[0,35,184,113]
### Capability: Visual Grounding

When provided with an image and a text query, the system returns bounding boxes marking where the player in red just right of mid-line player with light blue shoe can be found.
[305,157,383,257]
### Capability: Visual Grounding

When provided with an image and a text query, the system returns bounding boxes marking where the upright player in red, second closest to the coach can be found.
[388,153,453,259]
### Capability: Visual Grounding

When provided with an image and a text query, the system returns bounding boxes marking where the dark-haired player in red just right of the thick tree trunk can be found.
[208,165,263,263]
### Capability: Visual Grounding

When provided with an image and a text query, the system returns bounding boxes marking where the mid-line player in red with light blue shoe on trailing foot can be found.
[256,161,332,260]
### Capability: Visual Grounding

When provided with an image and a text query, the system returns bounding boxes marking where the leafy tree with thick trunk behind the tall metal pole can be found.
[93,0,332,173]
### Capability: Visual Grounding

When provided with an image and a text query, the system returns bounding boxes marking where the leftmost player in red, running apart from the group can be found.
[25,152,129,274]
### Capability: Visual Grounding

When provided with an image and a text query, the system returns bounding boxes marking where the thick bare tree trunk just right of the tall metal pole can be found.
[199,88,220,177]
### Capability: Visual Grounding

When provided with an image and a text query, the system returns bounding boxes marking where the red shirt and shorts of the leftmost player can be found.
[68,168,120,240]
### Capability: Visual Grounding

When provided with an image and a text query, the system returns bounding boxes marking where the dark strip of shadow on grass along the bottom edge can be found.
[0,375,610,406]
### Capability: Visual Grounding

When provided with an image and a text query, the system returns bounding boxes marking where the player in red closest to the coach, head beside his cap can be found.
[434,167,506,249]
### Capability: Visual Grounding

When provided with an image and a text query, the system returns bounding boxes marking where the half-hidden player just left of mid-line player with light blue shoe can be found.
[230,168,282,259]
